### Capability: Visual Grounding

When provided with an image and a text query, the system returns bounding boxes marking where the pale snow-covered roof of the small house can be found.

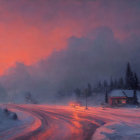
[110,89,139,97]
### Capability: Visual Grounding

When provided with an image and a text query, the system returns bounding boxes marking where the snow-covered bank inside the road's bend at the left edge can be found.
[0,104,40,140]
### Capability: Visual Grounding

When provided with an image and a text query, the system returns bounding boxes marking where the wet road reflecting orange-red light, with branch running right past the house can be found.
[0,105,140,140]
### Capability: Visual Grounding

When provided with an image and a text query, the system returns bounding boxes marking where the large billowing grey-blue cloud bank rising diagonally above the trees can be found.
[0,27,140,102]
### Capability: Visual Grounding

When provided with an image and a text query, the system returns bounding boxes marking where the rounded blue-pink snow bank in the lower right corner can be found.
[92,122,140,140]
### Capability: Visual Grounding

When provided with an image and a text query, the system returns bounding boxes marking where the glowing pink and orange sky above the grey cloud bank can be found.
[0,0,140,74]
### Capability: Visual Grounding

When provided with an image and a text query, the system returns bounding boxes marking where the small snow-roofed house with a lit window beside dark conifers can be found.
[108,89,140,106]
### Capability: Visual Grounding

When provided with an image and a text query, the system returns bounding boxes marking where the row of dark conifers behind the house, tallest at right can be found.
[74,63,140,98]
